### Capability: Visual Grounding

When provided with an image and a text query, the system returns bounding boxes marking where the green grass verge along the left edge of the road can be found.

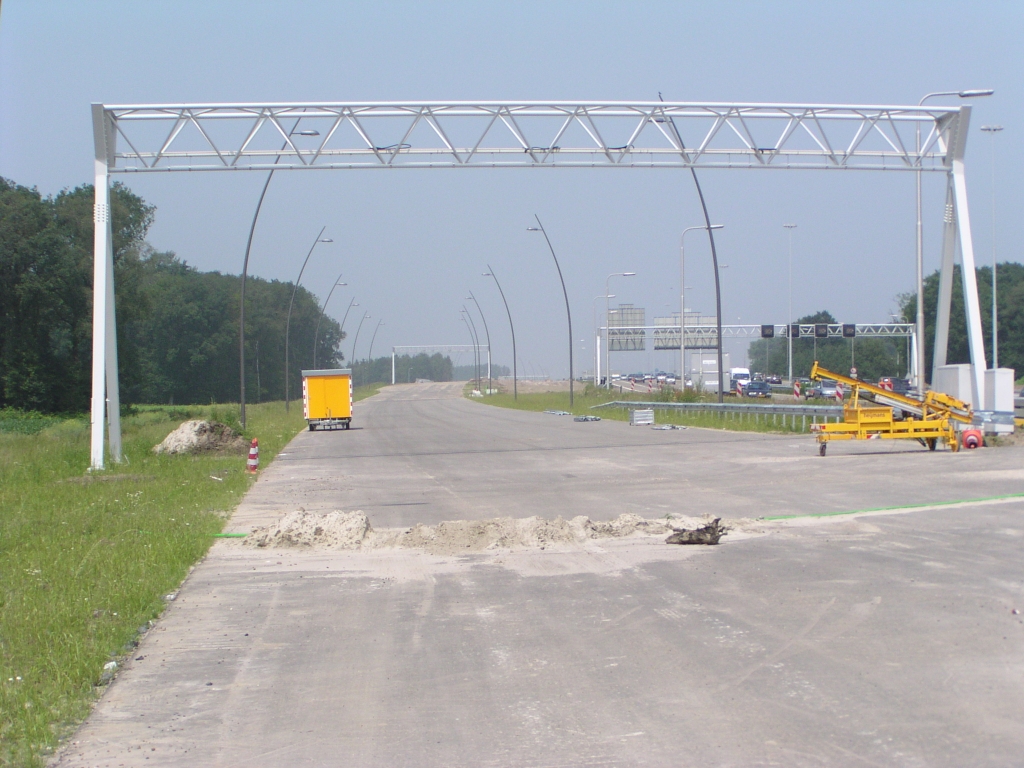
[0,394,305,766]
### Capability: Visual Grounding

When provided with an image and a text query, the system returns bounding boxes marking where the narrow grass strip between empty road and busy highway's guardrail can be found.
[470,384,806,433]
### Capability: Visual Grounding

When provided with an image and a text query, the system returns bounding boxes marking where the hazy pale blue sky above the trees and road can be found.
[0,0,1024,376]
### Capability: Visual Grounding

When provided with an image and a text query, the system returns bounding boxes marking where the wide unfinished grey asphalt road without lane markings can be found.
[57,385,1024,767]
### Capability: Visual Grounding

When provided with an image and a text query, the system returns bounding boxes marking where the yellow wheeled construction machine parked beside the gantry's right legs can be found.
[811,360,974,456]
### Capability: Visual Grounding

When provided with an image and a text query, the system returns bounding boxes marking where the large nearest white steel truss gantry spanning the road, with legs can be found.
[91,101,985,469]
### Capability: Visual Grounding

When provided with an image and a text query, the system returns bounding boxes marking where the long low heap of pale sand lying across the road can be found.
[243,510,707,554]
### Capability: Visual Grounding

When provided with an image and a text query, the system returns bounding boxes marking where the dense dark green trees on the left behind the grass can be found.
[0,179,342,413]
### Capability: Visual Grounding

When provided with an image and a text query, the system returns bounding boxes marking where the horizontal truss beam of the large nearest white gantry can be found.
[94,101,961,173]
